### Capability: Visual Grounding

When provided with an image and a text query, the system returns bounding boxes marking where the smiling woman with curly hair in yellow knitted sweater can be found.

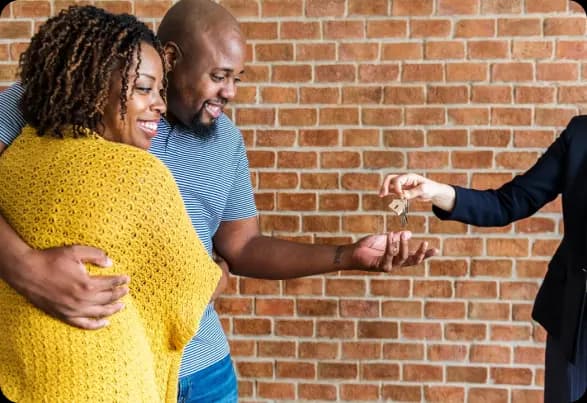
[0,6,220,402]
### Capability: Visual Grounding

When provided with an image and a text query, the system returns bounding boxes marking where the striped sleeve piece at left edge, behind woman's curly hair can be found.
[0,83,26,145]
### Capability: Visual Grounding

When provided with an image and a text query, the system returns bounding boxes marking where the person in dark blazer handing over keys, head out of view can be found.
[380,116,587,403]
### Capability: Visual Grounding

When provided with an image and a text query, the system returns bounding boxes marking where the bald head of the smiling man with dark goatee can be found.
[157,0,246,132]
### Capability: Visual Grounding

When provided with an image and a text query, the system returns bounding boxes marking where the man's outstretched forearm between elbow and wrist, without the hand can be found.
[229,235,351,280]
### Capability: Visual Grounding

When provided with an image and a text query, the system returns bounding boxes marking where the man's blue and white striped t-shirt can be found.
[0,84,257,377]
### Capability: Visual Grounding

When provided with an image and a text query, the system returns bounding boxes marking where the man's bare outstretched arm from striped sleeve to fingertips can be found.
[214,217,437,280]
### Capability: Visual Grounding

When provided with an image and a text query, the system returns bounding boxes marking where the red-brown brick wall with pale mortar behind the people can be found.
[0,0,587,403]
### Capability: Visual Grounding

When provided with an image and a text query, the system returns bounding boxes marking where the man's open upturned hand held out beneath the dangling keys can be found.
[349,231,438,273]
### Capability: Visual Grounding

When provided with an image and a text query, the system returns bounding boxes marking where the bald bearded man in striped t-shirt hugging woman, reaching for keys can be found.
[0,0,436,402]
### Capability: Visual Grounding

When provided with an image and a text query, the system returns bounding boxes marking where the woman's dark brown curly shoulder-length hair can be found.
[20,6,166,137]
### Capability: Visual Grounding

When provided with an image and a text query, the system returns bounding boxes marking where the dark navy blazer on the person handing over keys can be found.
[433,116,587,362]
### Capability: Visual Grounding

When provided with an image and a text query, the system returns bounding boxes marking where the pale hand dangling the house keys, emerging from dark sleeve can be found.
[379,174,455,211]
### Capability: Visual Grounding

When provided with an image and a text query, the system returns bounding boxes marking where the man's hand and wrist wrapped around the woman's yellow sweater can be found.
[3,246,130,330]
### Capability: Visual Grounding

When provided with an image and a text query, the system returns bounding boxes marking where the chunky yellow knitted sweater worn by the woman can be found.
[0,127,220,403]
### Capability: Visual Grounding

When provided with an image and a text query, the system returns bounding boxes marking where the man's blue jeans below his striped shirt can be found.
[177,354,238,403]
